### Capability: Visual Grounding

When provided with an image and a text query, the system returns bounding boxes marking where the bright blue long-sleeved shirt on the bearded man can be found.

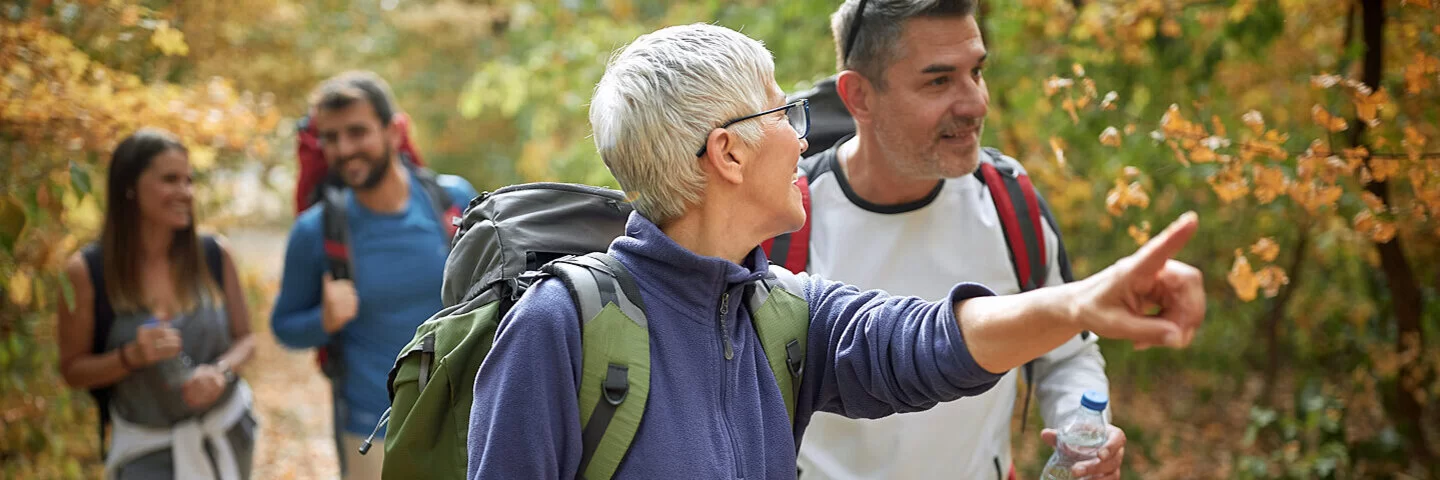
[271,174,475,435]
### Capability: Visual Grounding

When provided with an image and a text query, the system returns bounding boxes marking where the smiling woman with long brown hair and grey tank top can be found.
[59,128,256,480]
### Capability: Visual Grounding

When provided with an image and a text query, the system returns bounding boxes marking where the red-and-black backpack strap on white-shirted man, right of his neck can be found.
[975,148,1048,291]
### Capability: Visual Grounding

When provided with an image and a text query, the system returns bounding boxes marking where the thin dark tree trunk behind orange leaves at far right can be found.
[1351,0,1434,464]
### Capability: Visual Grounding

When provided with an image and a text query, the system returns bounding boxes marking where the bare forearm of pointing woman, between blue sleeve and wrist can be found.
[955,284,1081,373]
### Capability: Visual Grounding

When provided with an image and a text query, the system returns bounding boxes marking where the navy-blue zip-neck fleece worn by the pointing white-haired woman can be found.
[468,215,1001,479]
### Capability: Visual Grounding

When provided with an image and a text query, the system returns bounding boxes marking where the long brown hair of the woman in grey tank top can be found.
[101,128,225,313]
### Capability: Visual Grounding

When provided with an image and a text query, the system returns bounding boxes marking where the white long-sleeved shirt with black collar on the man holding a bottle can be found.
[799,141,1107,480]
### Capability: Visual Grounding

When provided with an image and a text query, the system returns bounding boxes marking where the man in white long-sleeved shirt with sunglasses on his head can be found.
[779,0,1125,480]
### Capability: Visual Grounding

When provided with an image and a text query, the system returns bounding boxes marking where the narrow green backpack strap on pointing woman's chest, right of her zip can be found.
[746,265,809,427]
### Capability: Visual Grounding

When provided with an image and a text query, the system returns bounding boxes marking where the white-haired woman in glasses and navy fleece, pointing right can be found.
[468,25,1205,479]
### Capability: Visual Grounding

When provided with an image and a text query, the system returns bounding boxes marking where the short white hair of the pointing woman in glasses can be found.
[590,23,775,223]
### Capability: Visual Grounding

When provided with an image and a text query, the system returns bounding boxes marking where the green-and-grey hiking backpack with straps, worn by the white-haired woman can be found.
[360,183,809,480]
